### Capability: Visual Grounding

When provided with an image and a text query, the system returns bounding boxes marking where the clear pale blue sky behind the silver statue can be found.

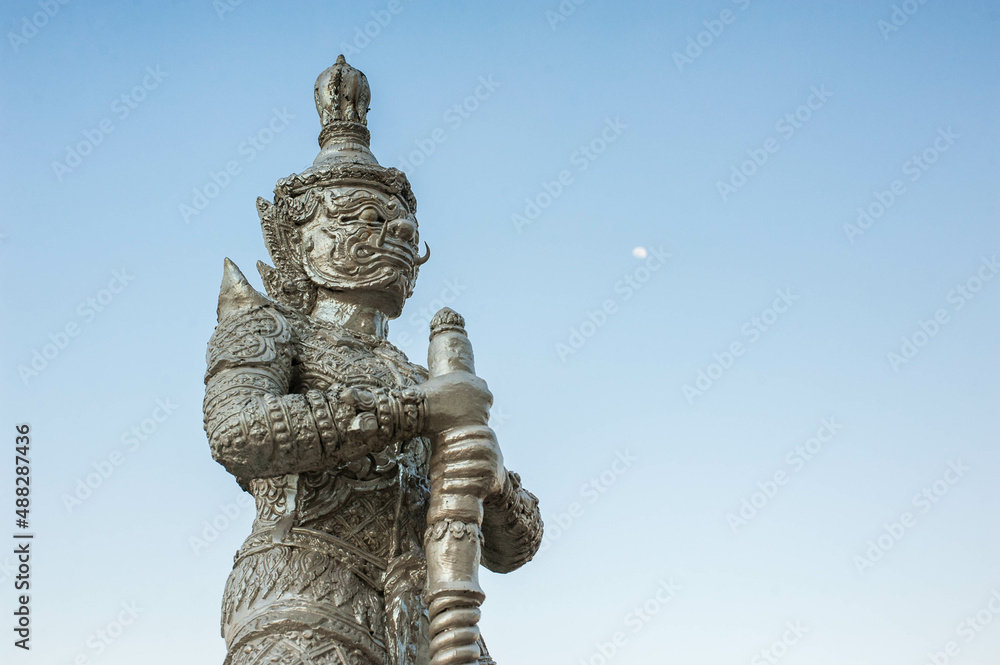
[0,0,1000,665]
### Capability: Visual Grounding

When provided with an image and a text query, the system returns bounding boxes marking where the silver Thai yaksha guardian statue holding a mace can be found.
[204,56,542,665]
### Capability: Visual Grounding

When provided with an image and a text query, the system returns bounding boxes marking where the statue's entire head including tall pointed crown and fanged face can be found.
[257,56,430,318]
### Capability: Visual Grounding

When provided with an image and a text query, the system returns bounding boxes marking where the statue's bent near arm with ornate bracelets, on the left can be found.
[204,286,425,483]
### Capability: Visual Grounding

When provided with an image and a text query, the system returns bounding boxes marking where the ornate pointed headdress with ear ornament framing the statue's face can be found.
[257,55,422,313]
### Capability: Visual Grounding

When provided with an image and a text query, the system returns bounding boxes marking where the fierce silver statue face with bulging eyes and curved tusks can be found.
[301,186,426,318]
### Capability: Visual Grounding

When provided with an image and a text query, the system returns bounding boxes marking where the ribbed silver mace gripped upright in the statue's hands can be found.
[424,307,496,665]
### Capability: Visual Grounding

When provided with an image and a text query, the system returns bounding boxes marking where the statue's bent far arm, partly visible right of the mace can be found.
[483,471,542,573]
